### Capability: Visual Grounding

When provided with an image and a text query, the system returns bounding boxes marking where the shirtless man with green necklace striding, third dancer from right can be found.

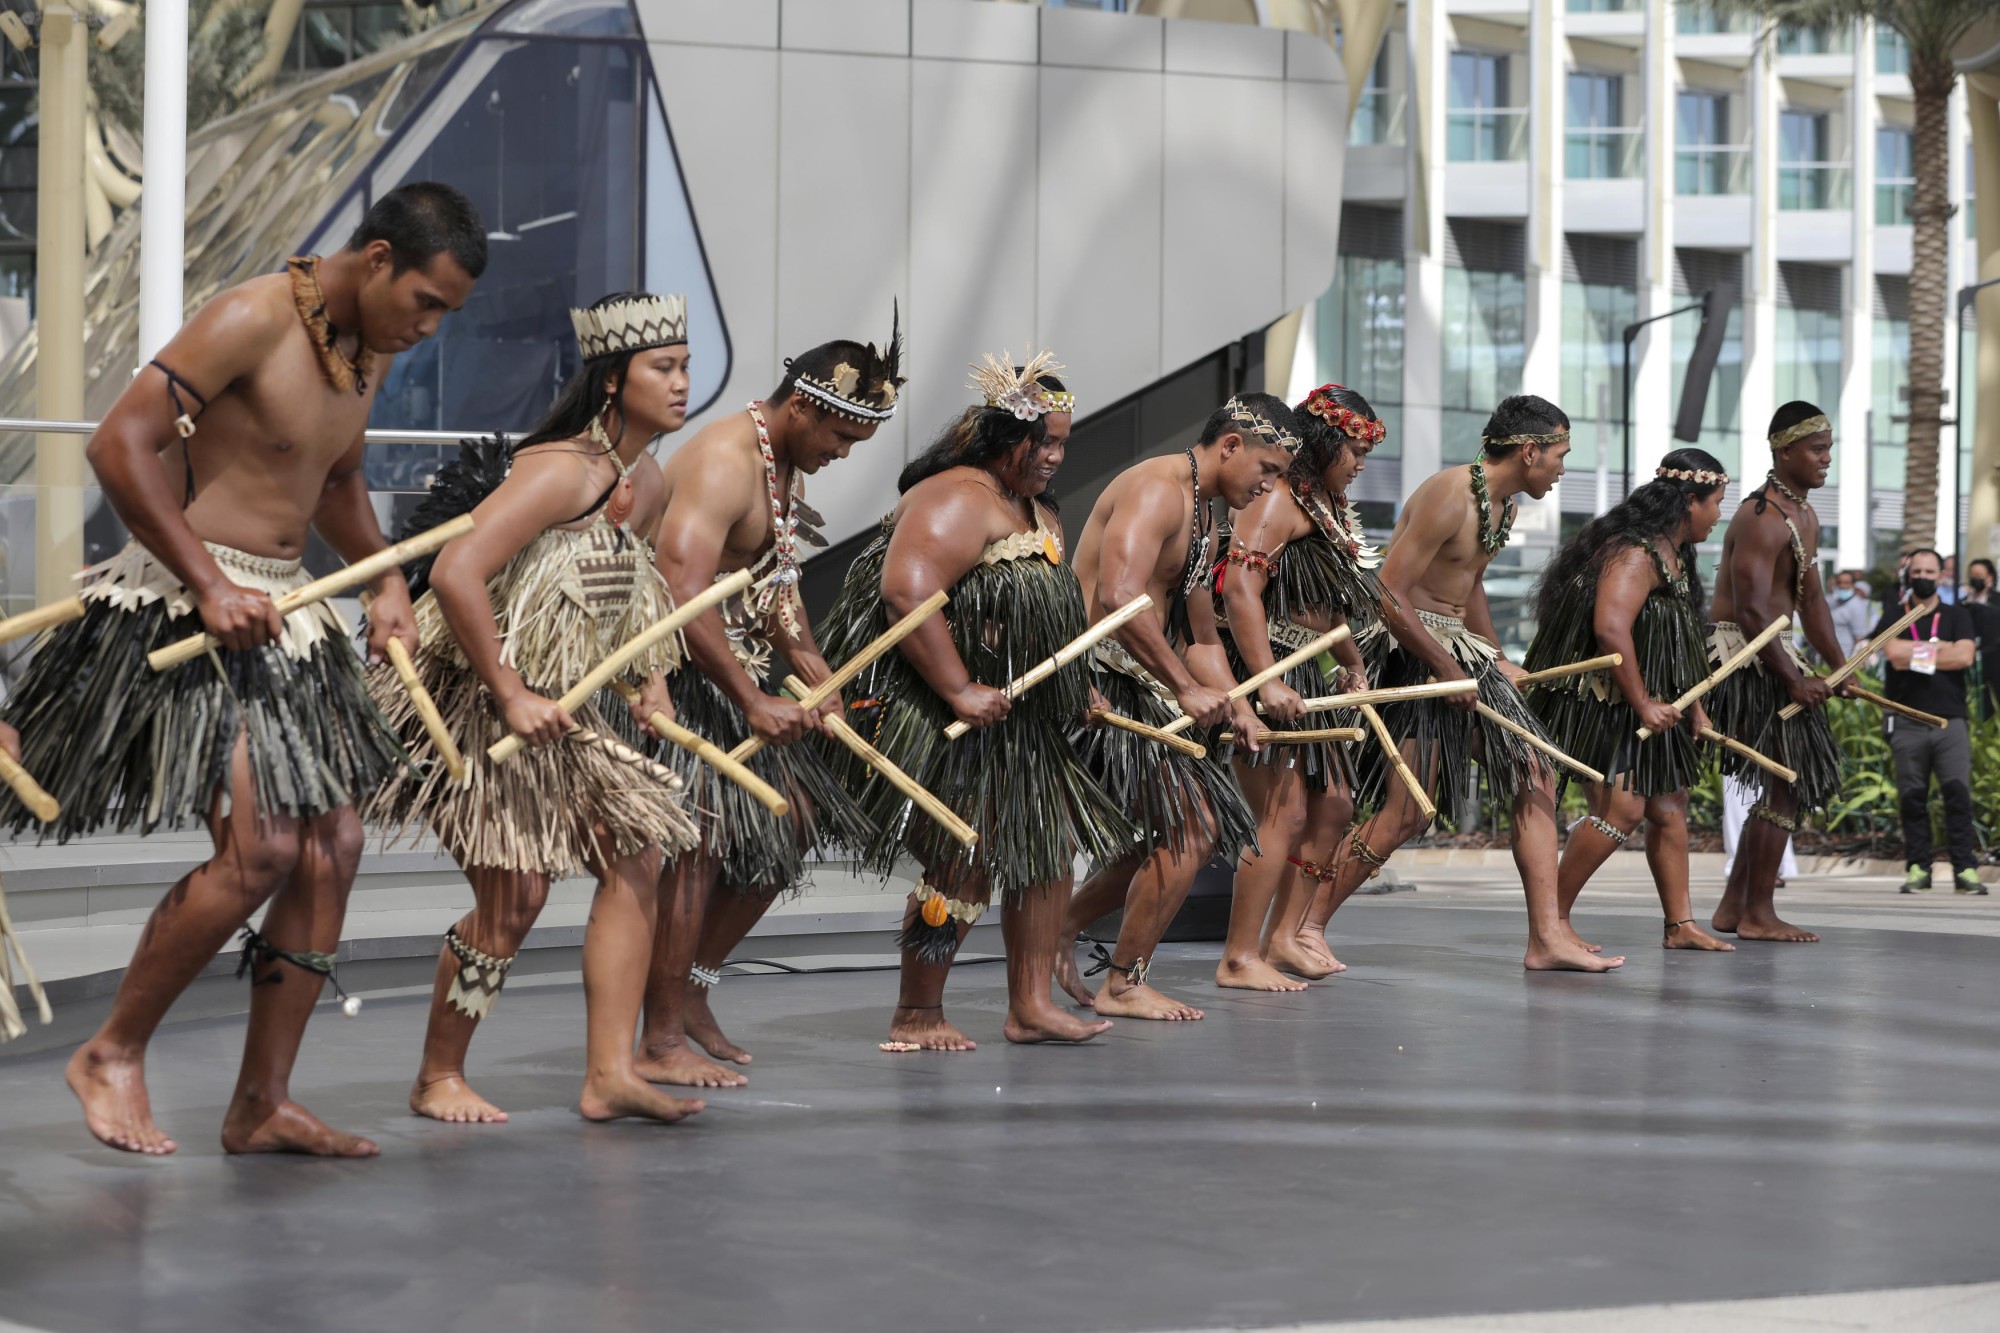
[1304,394,1624,973]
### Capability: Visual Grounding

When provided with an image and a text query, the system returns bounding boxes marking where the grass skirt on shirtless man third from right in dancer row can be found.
[1362,610,1552,825]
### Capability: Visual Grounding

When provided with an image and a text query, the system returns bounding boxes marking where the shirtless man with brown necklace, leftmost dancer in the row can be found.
[8,182,486,1157]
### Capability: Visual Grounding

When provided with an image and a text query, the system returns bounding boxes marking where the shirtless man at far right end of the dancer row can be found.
[1708,402,1848,945]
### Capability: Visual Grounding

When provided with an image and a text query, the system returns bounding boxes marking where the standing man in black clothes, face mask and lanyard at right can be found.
[1874,550,1986,895]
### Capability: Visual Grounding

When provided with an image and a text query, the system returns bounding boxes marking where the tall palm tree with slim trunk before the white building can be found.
[1726,0,1996,550]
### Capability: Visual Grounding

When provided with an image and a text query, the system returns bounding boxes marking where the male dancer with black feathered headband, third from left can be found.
[640,328,904,1087]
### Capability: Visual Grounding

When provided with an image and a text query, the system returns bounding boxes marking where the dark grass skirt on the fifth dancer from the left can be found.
[1072,640,1256,869]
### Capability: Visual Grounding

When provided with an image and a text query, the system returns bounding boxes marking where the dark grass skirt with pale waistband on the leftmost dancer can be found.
[0,542,406,843]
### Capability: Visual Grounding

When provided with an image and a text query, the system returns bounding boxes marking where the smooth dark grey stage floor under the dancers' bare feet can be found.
[0,899,2000,1333]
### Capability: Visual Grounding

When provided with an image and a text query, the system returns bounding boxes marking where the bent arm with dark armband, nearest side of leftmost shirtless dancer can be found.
[84,290,296,650]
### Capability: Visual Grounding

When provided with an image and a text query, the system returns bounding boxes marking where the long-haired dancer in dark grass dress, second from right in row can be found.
[1526,448,1734,953]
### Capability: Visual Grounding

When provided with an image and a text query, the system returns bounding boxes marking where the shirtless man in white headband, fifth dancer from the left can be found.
[1056,394,1298,1021]
